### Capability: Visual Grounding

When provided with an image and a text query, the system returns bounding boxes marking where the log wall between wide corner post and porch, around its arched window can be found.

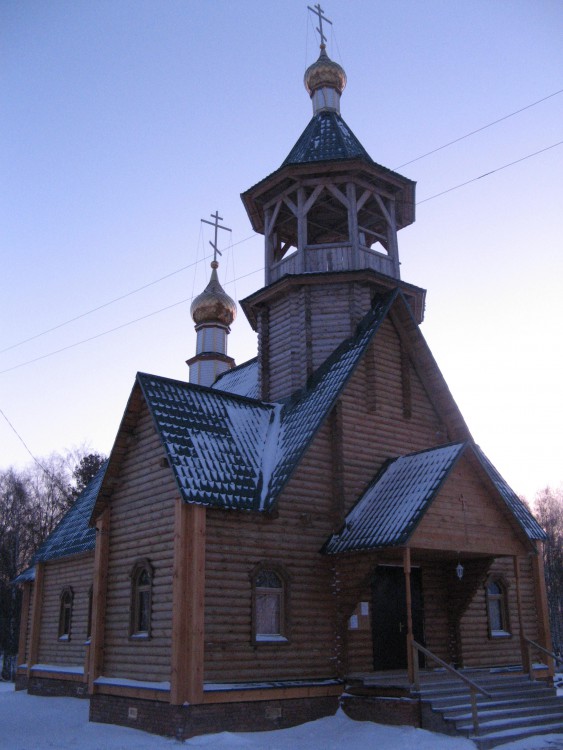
[204,425,336,682]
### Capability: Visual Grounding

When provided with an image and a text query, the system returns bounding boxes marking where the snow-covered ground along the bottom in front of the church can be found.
[0,682,563,750]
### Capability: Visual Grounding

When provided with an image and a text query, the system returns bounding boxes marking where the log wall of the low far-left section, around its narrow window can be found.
[37,551,94,667]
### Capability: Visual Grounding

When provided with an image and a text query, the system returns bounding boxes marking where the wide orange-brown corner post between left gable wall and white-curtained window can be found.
[170,498,206,705]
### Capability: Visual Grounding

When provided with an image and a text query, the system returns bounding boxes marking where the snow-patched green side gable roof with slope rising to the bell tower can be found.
[137,291,400,511]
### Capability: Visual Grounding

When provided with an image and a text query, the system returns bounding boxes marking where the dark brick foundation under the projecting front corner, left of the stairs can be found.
[90,694,338,740]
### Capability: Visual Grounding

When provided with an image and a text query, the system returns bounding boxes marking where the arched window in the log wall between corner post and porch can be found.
[252,566,288,643]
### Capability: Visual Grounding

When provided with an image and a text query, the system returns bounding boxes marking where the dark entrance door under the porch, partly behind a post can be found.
[371,565,424,670]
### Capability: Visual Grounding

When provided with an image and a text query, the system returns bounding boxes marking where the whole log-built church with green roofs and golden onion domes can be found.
[17,9,552,738]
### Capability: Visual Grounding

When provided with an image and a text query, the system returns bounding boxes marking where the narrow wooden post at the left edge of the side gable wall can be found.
[88,505,111,693]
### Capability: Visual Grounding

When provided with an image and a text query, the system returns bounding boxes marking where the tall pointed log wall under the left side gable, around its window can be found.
[103,403,178,682]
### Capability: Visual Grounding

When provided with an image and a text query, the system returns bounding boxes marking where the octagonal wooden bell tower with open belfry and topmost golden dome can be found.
[241,5,425,400]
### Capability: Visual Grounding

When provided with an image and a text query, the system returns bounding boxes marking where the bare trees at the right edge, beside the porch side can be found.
[534,487,563,654]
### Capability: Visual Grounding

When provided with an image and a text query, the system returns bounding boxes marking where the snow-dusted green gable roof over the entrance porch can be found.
[322,442,545,555]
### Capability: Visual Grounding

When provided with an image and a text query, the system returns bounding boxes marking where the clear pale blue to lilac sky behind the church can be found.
[0,0,563,506]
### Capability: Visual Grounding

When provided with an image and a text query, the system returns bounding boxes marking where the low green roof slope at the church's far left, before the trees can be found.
[33,461,107,564]
